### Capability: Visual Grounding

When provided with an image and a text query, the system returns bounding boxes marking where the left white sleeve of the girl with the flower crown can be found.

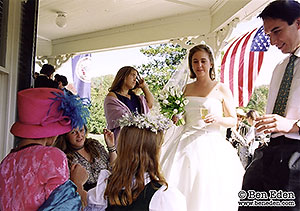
[85,170,110,211]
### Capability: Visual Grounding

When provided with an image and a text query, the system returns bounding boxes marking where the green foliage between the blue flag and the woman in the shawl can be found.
[88,75,114,134]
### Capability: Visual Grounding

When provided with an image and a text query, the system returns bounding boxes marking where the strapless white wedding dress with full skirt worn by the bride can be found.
[161,96,244,211]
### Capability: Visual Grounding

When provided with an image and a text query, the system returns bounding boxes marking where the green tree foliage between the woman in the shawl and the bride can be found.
[137,44,186,96]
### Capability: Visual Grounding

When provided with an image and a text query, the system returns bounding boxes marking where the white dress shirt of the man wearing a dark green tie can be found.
[266,48,300,140]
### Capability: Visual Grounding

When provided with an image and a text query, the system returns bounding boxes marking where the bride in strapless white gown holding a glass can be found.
[161,44,244,211]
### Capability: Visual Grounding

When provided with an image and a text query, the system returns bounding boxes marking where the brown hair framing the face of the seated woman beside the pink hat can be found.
[54,126,100,167]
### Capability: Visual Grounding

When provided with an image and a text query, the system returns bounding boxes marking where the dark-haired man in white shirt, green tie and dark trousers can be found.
[239,0,300,211]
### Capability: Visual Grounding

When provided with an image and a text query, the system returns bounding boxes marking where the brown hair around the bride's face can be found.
[188,44,216,81]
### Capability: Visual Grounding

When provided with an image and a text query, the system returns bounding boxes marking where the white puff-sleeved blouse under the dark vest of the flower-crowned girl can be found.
[85,170,186,211]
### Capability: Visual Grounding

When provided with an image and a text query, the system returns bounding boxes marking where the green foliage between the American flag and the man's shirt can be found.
[246,85,269,115]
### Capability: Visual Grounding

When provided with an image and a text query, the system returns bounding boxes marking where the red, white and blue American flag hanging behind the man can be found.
[221,26,270,106]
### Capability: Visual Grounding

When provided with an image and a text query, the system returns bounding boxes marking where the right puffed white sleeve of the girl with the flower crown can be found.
[149,186,187,211]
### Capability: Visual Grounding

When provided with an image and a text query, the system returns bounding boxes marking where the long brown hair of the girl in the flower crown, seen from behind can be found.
[104,127,167,206]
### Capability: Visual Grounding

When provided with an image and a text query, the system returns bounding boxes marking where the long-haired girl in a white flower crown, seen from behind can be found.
[85,114,186,211]
